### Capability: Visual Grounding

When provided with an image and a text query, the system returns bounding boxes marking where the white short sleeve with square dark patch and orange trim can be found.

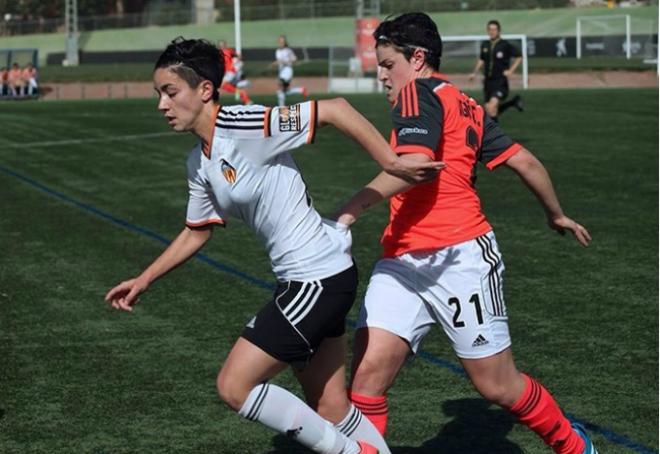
[235,101,318,163]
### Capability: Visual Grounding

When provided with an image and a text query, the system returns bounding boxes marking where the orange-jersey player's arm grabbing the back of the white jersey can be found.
[334,153,431,226]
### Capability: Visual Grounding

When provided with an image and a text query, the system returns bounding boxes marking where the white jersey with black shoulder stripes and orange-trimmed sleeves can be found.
[186,101,353,281]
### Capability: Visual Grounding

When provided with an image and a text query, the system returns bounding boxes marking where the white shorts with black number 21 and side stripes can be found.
[357,232,511,359]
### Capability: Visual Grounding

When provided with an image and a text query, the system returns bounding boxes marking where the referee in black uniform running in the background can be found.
[470,20,523,120]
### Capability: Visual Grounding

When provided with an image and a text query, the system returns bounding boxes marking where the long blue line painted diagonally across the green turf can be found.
[0,164,658,454]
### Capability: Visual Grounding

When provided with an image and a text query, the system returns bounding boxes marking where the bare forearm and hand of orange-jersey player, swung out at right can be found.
[504,147,591,246]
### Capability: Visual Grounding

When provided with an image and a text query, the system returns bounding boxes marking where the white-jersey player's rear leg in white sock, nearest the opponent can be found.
[294,335,390,454]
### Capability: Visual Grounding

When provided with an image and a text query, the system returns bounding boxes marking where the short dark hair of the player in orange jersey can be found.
[373,13,442,71]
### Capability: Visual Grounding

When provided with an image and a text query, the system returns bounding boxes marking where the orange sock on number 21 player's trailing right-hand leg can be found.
[509,374,585,454]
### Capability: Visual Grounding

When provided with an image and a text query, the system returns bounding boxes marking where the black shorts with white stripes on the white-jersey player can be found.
[241,264,358,369]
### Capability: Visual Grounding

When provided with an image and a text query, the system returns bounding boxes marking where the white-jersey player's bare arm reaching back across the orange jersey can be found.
[318,98,444,183]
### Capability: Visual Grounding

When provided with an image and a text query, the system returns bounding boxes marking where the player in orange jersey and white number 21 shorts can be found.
[337,13,596,454]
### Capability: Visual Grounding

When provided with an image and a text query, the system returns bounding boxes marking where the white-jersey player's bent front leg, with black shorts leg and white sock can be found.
[217,282,361,454]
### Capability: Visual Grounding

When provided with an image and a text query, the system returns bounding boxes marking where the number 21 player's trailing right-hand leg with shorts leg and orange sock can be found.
[436,232,596,454]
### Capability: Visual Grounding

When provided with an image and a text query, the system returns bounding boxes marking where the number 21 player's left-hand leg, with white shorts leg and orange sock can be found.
[350,256,435,434]
